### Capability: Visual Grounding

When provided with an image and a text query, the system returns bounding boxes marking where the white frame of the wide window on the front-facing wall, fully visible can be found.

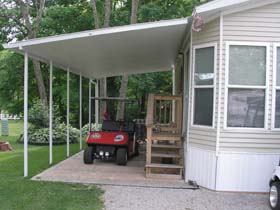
[224,41,270,131]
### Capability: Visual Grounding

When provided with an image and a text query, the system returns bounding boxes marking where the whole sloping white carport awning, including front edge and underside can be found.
[4,18,188,78]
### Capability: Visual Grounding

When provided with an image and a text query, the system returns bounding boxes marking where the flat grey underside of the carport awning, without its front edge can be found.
[25,25,186,78]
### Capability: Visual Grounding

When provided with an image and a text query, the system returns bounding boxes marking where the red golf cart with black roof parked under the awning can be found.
[84,98,139,165]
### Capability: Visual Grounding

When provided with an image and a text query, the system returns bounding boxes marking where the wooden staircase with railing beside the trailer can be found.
[146,94,183,179]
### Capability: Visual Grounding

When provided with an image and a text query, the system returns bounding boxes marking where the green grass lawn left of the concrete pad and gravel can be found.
[0,121,103,210]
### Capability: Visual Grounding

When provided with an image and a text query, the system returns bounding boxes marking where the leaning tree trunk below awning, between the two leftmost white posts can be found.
[32,59,48,106]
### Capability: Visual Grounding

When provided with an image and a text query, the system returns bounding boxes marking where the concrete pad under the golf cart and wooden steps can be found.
[32,151,195,189]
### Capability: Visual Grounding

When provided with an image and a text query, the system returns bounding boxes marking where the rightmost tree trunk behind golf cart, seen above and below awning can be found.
[116,0,139,120]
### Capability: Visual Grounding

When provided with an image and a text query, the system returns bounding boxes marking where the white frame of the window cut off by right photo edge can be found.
[271,43,280,131]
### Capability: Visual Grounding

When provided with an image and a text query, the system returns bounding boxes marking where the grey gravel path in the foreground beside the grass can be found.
[102,186,270,210]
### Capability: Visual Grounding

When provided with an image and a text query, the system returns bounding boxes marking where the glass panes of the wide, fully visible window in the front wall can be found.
[227,45,267,128]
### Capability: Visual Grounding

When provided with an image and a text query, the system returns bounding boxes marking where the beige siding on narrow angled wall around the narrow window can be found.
[188,18,220,151]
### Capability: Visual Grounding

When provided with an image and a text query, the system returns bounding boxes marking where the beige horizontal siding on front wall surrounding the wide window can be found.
[219,3,280,153]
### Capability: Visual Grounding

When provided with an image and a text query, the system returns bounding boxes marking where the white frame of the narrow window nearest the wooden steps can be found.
[191,42,218,129]
